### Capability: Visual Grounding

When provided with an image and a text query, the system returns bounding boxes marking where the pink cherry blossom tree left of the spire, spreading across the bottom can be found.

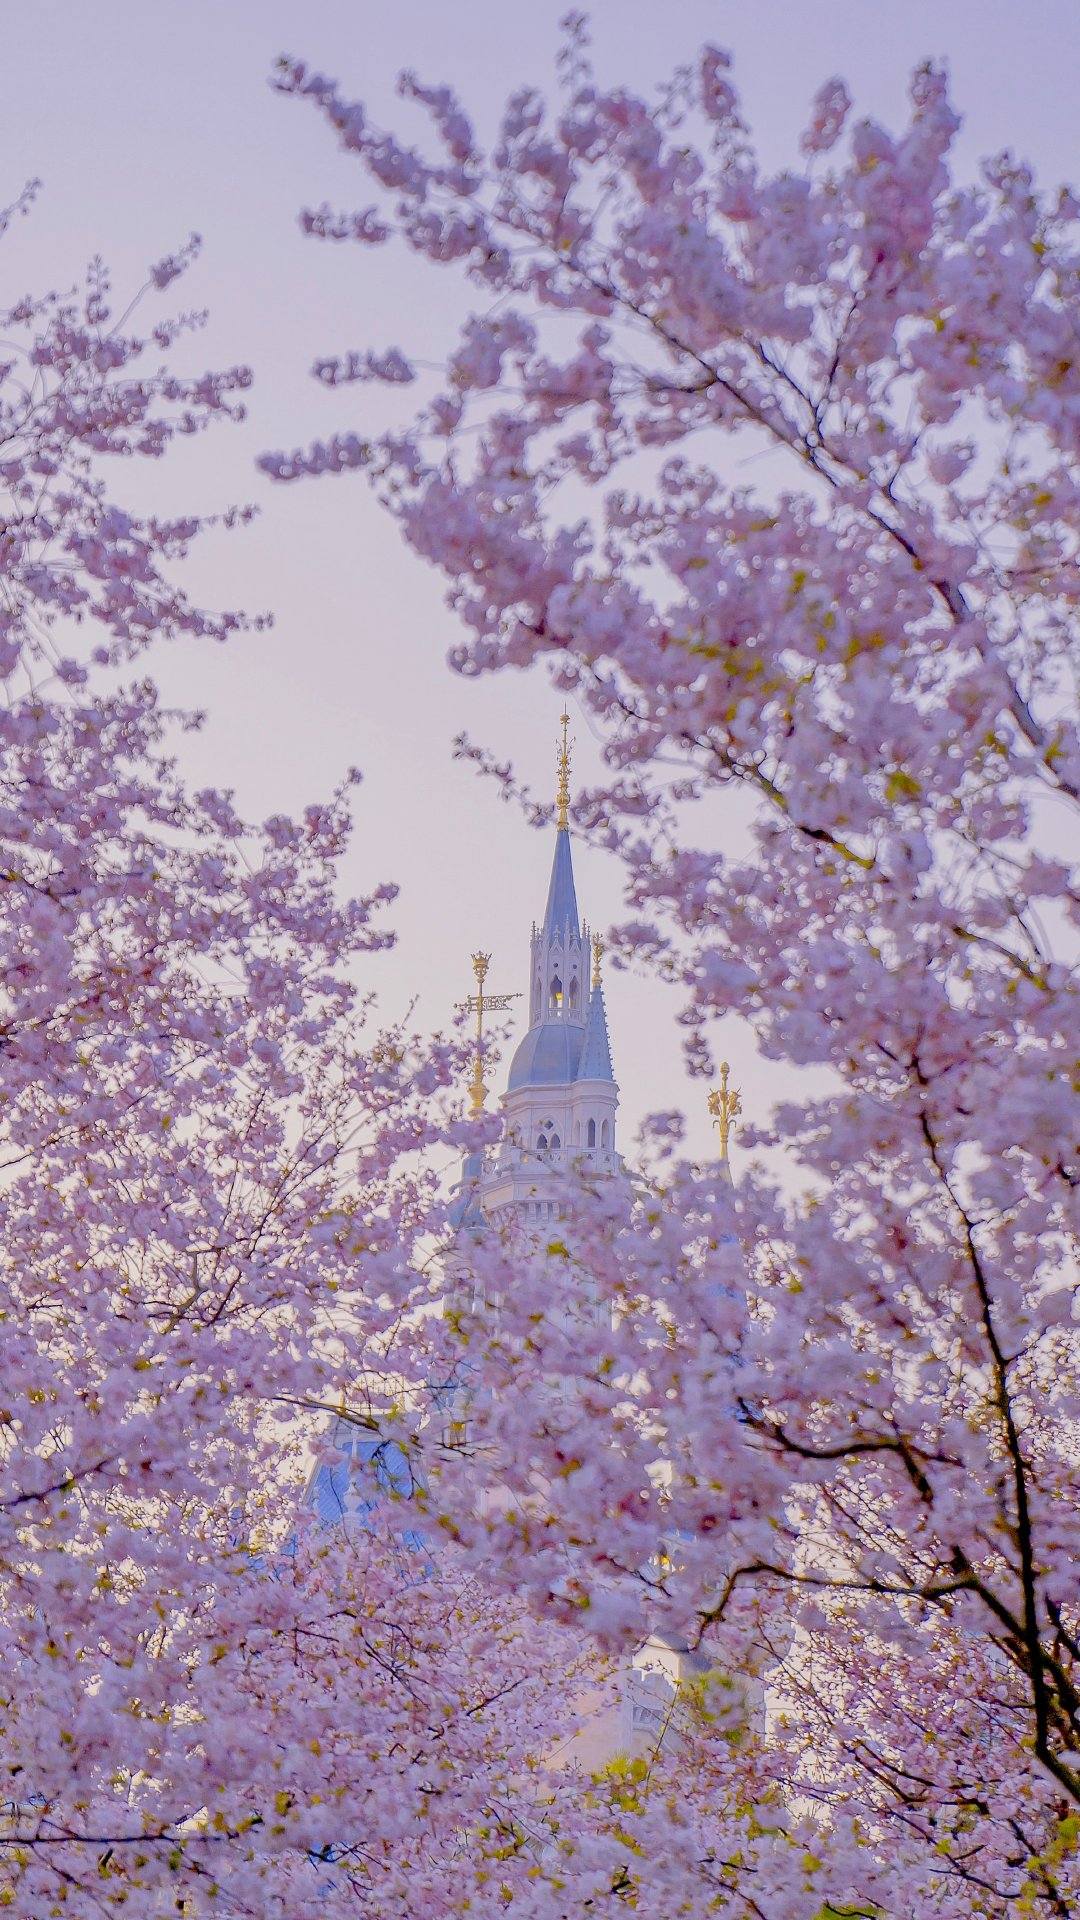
[0,180,786,1920]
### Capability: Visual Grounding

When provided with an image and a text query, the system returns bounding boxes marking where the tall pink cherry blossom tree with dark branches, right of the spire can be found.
[263,17,1080,1920]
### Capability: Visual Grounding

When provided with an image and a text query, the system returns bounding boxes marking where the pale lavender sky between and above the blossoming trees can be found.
[8,0,1080,1150]
